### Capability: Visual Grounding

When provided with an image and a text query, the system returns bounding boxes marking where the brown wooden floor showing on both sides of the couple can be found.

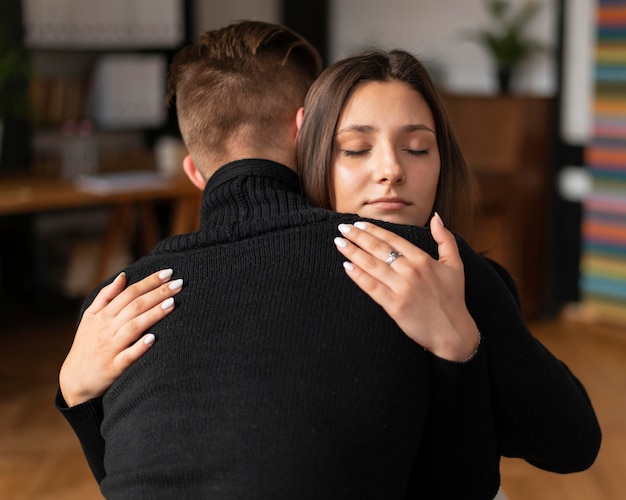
[0,294,626,500]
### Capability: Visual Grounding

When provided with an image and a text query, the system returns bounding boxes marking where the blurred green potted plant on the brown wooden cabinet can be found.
[469,0,545,93]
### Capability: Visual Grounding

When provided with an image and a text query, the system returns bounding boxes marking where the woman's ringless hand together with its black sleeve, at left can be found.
[55,269,182,482]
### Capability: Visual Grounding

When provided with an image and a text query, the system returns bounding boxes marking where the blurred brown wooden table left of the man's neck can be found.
[0,176,202,283]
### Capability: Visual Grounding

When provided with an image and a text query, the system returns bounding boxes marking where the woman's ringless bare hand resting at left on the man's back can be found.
[59,269,183,406]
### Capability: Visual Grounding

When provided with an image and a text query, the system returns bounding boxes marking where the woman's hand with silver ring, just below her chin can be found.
[335,214,479,361]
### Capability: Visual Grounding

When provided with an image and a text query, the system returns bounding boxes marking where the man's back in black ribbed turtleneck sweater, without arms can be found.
[102,160,434,499]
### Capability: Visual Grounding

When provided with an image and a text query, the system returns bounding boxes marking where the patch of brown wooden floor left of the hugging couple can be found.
[0,301,103,500]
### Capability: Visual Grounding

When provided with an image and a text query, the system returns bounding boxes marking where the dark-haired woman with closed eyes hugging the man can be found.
[62,47,599,496]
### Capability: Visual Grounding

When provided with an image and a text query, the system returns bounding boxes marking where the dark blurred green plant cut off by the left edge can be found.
[0,22,30,164]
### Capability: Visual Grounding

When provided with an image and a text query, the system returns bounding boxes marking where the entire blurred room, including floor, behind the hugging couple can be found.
[0,0,626,499]
